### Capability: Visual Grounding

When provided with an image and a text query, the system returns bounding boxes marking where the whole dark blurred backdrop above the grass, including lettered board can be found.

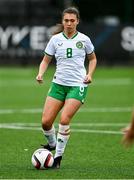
[0,0,134,66]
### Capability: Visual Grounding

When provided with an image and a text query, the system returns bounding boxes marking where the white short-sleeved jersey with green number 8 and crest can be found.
[45,32,94,86]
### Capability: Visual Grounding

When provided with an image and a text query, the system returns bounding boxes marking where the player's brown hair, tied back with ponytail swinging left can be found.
[53,7,80,35]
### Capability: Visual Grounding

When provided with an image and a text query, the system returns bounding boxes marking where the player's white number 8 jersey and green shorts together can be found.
[45,32,94,103]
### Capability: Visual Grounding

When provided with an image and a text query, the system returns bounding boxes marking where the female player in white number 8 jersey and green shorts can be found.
[36,7,97,168]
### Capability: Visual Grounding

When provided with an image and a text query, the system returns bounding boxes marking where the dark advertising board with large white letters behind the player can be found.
[0,23,134,65]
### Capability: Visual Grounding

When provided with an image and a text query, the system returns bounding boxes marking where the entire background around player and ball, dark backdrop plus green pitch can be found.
[0,0,134,179]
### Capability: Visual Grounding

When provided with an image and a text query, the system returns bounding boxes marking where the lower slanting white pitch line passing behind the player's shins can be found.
[0,123,123,135]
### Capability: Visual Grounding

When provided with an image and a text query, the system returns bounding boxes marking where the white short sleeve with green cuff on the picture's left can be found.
[45,37,55,56]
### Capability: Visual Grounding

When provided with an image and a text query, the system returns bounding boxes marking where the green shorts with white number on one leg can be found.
[48,83,87,104]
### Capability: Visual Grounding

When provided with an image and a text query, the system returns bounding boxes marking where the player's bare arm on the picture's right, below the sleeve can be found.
[84,52,97,84]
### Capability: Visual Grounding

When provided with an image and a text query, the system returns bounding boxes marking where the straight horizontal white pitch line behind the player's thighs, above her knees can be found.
[0,107,132,114]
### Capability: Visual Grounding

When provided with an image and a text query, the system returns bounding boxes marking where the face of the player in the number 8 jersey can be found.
[62,13,79,32]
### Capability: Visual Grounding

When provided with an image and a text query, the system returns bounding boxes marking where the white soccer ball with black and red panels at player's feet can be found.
[31,148,54,169]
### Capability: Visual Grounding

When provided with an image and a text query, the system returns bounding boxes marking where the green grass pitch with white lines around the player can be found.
[0,67,134,179]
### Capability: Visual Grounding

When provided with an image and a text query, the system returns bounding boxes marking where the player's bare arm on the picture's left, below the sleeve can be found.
[36,54,52,83]
